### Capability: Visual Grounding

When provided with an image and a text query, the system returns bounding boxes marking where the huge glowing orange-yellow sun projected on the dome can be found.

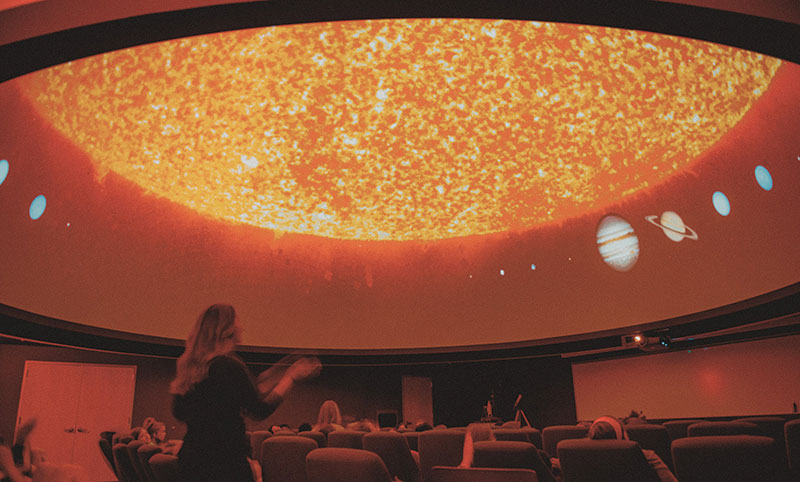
[19,19,780,240]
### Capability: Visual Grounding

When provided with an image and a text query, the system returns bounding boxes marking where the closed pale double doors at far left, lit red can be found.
[17,361,136,481]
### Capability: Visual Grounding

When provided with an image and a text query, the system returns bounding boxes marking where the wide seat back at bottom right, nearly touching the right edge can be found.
[672,435,781,482]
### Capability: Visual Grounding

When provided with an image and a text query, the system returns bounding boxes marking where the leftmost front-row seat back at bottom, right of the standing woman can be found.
[304,447,392,482]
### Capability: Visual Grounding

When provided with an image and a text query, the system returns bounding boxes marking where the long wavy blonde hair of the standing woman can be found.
[169,304,236,395]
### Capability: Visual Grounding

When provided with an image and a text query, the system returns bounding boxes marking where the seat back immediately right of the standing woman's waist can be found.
[259,435,317,482]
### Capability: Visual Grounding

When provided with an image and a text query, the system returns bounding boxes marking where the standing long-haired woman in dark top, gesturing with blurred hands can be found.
[170,304,320,482]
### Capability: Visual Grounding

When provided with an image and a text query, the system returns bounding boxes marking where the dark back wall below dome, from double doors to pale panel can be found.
[0,338,575,438]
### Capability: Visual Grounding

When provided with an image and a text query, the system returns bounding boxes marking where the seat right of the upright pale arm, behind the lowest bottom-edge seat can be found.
[472,440,555,482]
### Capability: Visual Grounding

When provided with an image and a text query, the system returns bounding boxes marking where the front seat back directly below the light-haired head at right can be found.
[557,439,660,482]
